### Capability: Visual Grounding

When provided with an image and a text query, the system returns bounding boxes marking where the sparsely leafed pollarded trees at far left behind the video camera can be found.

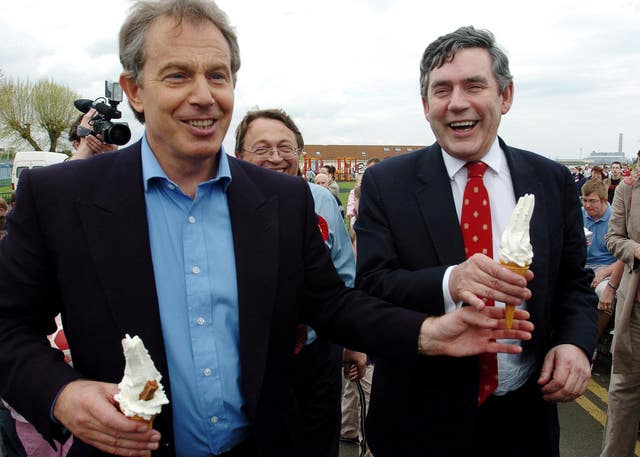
[0,79,79,151]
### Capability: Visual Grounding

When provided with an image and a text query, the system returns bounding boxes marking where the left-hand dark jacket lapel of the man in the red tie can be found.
[415,143,465,265]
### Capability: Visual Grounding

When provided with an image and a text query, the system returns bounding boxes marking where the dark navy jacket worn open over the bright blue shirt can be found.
[0,142,425,457]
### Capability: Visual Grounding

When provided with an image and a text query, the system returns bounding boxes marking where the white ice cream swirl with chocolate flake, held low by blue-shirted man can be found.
[115,334,169,420]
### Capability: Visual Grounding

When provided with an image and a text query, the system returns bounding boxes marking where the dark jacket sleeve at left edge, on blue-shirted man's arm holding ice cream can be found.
[0,171,79,440]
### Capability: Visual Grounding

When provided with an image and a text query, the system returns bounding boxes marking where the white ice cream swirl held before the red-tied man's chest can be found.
[500,194,535,267]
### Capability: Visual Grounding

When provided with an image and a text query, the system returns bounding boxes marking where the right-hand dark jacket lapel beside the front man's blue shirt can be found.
[228,158,281,417]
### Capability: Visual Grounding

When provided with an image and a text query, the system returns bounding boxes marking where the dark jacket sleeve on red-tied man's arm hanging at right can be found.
[548,169,597,357]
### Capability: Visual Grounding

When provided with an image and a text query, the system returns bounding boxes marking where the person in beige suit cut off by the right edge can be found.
[600,163,640,457]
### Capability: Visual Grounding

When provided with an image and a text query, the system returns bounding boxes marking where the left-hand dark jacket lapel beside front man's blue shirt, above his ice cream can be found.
[76,142,172,440]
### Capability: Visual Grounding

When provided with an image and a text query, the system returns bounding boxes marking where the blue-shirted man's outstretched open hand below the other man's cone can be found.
[420,306,533,357]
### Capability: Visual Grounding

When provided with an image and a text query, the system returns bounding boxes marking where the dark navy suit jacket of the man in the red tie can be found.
[356,140,597,457]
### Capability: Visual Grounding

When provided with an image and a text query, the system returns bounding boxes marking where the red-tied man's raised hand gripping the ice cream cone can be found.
[449,254,533,310]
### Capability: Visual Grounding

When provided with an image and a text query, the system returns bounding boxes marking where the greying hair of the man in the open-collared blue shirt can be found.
[119,0,240,123]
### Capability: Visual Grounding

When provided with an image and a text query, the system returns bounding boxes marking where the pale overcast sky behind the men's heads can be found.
[0,0,640,158]
